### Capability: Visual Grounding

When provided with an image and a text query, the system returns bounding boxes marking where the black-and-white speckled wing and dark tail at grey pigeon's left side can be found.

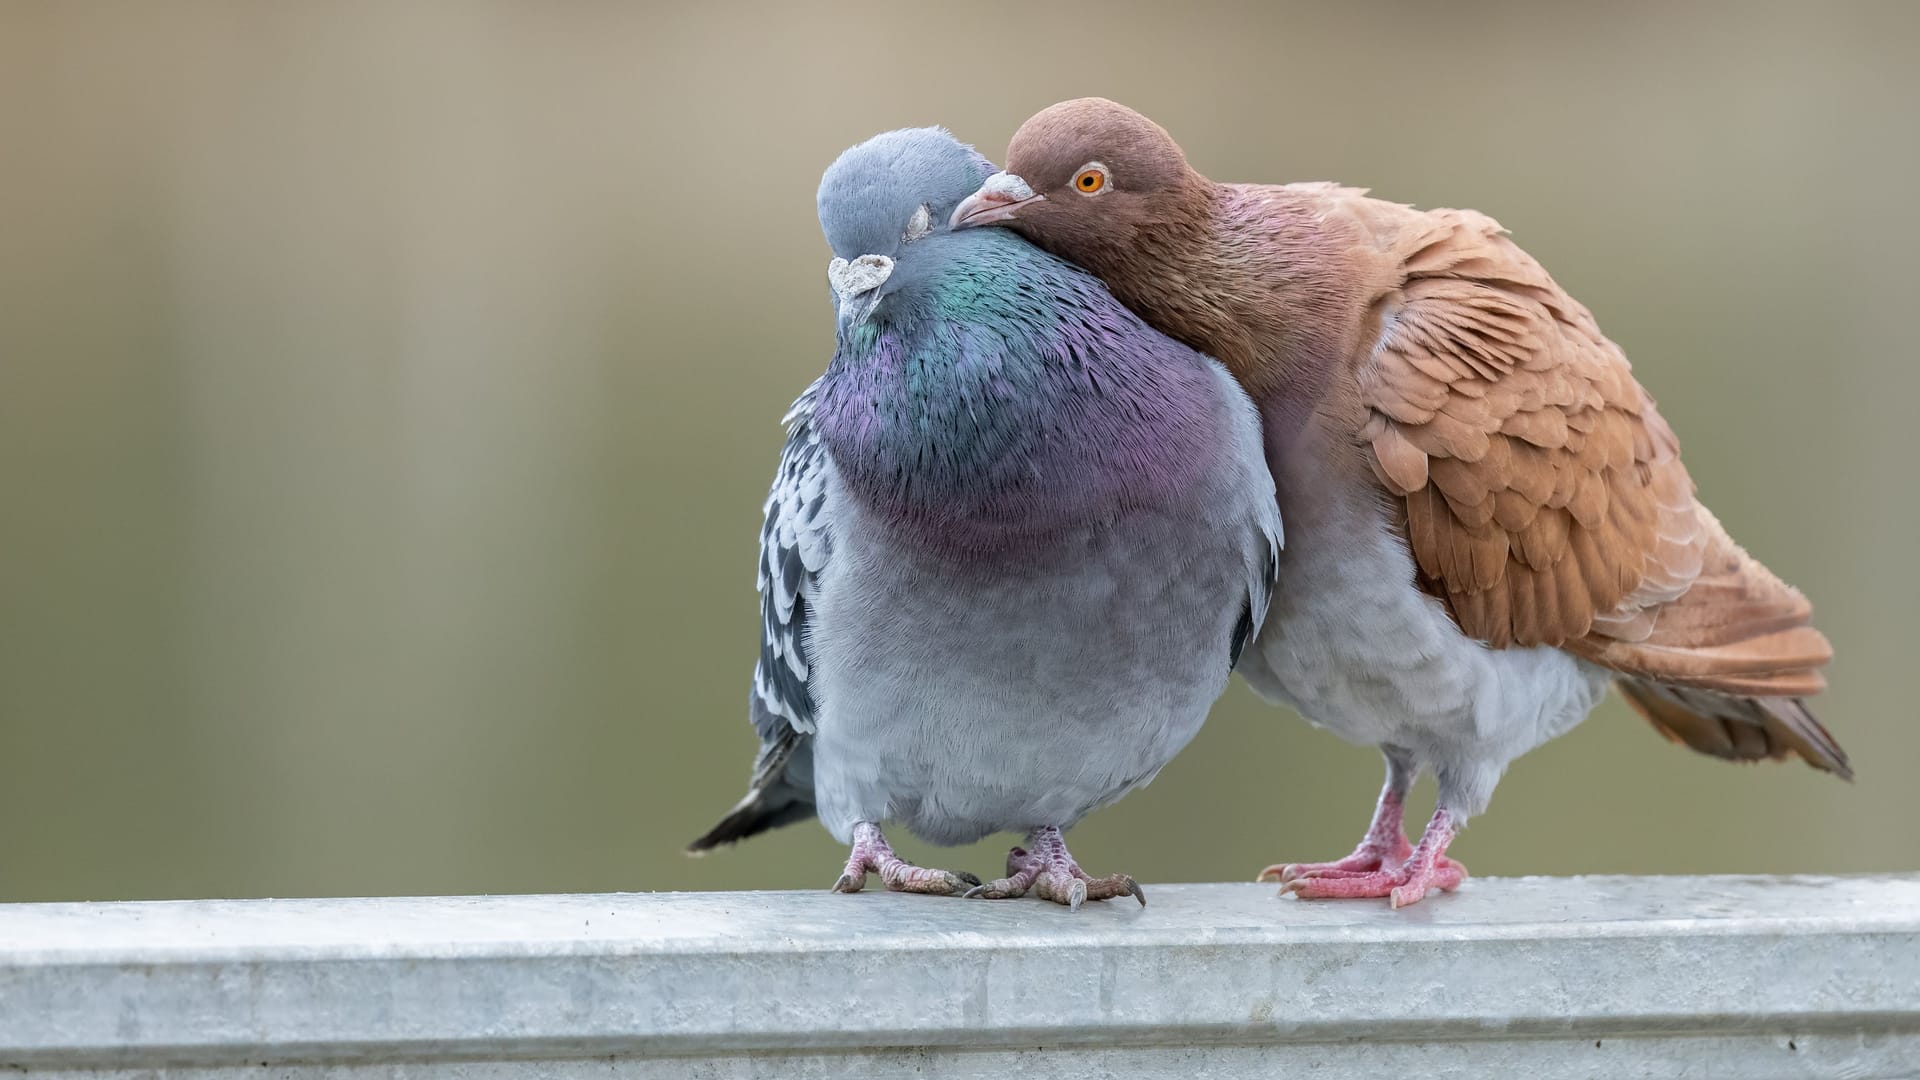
[687,380,833,851]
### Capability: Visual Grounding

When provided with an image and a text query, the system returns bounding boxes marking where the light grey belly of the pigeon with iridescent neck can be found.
[812,500,1260,844]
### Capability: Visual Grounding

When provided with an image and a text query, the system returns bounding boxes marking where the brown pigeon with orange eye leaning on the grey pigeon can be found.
[952,98,1851,907]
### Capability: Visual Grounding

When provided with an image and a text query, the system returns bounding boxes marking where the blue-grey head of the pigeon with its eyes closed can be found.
[816,127,993,327]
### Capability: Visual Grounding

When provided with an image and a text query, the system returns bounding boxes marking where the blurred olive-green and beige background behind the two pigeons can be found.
[0,0,1920,899]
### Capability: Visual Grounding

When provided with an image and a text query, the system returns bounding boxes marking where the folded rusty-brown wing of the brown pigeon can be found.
[1357,209,1832,711]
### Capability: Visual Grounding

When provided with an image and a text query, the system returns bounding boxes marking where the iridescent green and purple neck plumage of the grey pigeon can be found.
[814,248,1221,550]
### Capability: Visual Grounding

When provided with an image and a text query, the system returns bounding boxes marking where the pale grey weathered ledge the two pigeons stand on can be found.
[0,876,1920,1080]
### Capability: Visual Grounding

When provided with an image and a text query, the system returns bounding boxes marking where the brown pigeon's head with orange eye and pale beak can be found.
[952,98,1206,263]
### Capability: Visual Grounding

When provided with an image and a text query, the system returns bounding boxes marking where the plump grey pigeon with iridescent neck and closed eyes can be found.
[689,129,1281,909]
